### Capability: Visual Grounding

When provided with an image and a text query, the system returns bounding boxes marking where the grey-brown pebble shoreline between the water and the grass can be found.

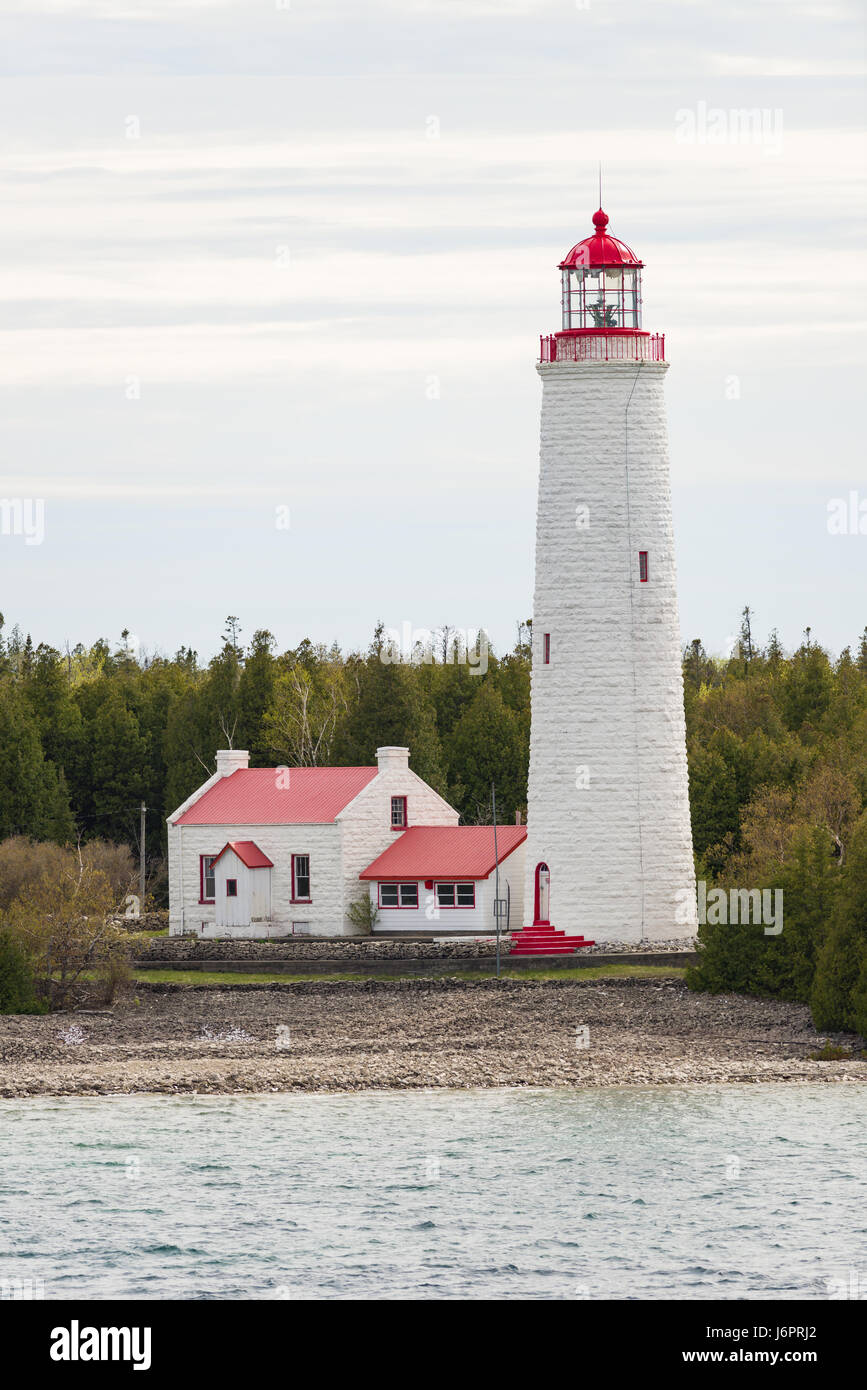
[0,979,867,1098]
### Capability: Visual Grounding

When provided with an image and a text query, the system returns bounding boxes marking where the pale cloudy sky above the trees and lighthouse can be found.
[0,0,867,659]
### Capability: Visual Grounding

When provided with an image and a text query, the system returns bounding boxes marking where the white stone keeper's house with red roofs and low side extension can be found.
[168,748,525,937]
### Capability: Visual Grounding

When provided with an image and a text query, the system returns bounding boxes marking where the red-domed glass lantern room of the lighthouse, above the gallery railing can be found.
[560,209,643,334]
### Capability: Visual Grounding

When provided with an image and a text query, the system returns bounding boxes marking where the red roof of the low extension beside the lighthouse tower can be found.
[358,826,527,880]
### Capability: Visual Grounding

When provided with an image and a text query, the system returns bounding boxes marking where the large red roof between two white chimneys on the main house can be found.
[174,767,379,826]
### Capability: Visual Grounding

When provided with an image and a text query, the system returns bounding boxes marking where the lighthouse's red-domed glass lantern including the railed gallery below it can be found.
[540,209,666,361]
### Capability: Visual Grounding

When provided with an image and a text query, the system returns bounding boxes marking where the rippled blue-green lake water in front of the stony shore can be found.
[0,1084,867,1300]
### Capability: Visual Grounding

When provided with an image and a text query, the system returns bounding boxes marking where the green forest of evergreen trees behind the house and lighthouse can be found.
[0,609,867,1031]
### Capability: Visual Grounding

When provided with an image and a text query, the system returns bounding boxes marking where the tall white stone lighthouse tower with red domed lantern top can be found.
[524,209,696,942]
